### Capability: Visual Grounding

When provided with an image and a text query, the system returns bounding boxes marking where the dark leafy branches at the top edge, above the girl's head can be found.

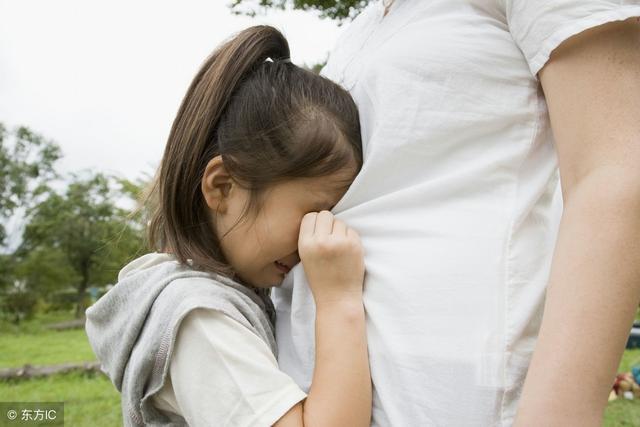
[229,0,369,24]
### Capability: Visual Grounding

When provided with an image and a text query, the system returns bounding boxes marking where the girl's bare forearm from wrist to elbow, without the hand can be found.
[304,296,371,427]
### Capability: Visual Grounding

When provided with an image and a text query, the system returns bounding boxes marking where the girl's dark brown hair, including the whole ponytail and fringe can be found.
[146,26,362,277]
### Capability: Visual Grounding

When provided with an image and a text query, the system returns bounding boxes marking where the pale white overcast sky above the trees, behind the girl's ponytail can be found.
[0,0,344,179]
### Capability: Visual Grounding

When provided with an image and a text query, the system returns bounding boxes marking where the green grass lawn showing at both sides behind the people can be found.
[0,313,640,427]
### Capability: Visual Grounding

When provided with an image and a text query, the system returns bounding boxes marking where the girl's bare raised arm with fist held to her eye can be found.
[275,211,371,427]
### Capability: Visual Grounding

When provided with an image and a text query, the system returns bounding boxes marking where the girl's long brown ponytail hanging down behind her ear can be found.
[149,26,289,274]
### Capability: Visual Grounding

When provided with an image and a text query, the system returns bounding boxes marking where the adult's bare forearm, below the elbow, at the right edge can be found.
[515,169,640,427]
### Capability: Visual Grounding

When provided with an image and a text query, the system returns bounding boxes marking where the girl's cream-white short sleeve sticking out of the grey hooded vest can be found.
[153,309,306,427]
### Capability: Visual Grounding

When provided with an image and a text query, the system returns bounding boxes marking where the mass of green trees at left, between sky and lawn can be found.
[0,123,147,320]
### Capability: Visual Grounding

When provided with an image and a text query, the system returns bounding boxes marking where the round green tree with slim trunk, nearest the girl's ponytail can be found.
[16,173,143,317]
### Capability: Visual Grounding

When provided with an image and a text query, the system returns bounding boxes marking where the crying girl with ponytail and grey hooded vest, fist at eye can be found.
[86,26,371,426]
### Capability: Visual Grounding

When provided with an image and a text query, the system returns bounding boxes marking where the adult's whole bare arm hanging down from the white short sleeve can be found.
[515,18,640,426]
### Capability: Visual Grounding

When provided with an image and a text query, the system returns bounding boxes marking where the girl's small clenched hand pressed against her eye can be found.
[298,211,364,305]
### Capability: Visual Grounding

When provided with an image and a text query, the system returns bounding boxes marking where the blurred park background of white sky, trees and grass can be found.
[0,0,640,426]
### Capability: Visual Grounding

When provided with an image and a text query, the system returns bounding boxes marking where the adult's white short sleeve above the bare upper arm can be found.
[502,0,640,76]
